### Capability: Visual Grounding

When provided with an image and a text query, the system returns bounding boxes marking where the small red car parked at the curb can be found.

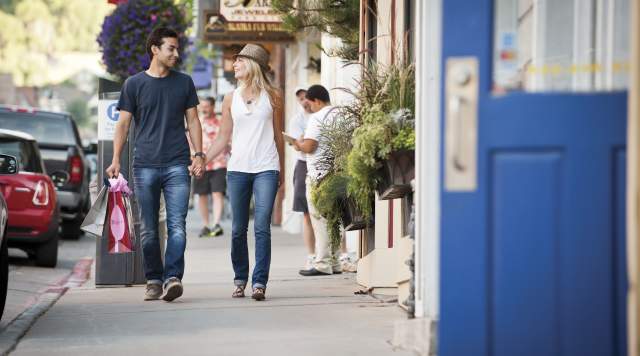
[0,129,67,267]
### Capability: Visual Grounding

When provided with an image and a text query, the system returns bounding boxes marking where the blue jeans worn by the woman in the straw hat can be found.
[227,171,280,288]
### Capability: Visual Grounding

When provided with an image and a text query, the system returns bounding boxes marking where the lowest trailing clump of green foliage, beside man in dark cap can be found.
[311,173,348,248]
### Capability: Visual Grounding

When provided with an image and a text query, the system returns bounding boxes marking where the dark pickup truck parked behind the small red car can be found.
[0,106,91,238]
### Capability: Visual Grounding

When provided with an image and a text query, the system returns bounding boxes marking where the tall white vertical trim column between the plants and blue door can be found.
[414,0,442,320]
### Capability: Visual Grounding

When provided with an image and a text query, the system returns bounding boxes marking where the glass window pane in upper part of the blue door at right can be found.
[493,0,629,92]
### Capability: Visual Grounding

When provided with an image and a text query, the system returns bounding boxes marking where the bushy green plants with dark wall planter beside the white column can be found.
[346,61,415,206]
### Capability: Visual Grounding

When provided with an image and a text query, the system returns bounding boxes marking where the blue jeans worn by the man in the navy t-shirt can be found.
[133,165,191,284]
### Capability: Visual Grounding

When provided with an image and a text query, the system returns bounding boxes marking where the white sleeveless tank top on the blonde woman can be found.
[227,88,280,173]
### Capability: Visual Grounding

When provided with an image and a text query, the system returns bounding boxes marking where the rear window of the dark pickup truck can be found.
[0,114,76,145]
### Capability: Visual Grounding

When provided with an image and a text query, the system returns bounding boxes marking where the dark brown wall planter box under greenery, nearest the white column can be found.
[377,150,416,200]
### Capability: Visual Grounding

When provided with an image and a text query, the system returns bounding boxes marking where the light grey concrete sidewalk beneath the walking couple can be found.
[7,210,411,356]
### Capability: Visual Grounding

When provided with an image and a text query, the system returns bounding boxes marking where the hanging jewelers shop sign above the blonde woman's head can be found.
[203,0,293,43]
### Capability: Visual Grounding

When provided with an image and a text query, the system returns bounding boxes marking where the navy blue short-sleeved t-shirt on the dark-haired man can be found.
[118,71,198,168]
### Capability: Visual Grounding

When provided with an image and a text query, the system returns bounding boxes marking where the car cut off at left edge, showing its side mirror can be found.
[0,154,18,320]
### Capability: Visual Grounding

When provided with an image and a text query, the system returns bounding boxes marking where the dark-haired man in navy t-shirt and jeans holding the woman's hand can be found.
[106,27,205,301]
